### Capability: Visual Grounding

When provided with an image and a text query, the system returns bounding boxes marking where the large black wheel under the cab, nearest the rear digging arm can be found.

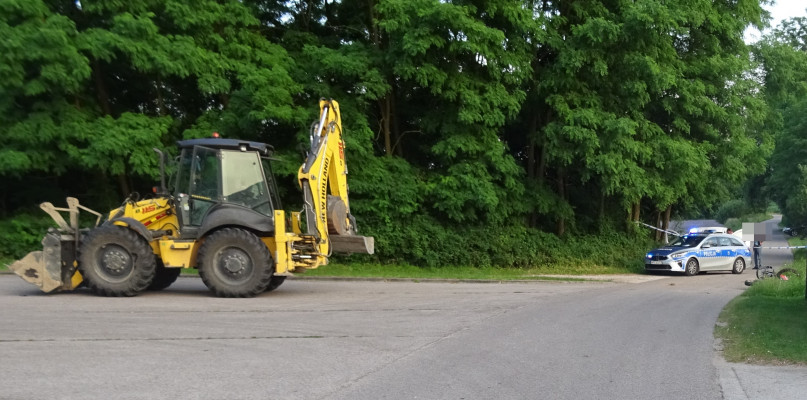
[198,228,274,297]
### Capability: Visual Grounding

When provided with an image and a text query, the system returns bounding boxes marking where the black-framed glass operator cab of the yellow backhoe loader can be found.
[174,138,281,239]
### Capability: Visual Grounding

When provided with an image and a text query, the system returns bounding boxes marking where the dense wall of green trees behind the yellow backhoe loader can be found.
[0,0,792,266]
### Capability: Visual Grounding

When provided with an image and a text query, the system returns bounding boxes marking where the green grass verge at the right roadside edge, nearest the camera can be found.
[715,240,807,365]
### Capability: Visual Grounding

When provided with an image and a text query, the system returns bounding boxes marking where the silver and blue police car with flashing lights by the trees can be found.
[644,232,751,276]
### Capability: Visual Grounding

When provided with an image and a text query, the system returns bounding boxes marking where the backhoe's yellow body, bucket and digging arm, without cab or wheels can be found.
[10,100,374,292]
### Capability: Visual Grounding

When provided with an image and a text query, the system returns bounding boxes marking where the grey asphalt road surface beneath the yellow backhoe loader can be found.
[0,217,804,399]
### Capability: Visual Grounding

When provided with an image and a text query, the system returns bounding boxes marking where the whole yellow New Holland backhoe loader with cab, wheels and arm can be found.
[10,99,374,297]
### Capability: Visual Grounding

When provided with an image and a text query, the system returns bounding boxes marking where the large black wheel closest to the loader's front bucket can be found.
[78,225,156,297]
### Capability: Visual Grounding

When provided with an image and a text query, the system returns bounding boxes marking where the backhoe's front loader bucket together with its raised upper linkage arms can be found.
[8,197,101,293]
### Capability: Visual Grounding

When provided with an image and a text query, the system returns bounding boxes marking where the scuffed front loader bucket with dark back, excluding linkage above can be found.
[9,231,81,293]
